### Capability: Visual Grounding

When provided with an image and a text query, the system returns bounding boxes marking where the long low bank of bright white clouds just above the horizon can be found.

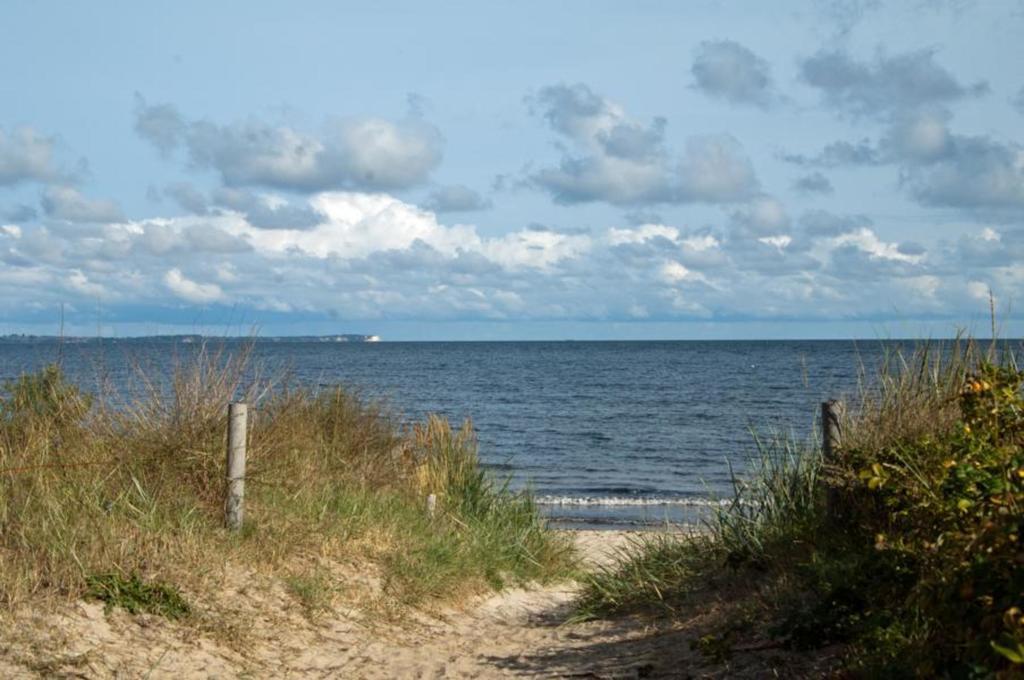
[0,188,1024,329]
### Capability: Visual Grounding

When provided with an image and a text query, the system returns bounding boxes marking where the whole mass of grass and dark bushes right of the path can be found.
[578,339,1024,677]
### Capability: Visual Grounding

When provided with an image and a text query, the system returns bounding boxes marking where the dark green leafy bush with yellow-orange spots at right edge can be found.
[844,360,1024,673]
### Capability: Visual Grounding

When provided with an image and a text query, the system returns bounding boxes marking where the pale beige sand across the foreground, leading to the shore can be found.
[0,532,798,678]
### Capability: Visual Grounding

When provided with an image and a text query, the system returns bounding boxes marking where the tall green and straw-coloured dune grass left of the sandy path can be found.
[0,348,573,615]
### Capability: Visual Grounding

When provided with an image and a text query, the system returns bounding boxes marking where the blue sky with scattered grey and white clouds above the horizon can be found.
[0,0,1024,340]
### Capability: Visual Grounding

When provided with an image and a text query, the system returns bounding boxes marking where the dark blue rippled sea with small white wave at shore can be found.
[0,341,884,526]
